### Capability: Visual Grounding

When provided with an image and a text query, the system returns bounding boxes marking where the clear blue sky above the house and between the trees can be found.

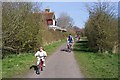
[42,2,118,28]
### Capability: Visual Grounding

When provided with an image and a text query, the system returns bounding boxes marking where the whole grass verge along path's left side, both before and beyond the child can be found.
[2,41,64,78]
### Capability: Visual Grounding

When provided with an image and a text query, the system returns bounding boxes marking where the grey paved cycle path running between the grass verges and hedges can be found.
[16,44,84,78]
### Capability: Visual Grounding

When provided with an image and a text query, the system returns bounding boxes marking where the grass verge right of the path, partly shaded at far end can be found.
[74,37,118,78]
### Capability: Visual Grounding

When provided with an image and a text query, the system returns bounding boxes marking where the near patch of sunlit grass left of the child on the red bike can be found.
[2,53,35,78]
